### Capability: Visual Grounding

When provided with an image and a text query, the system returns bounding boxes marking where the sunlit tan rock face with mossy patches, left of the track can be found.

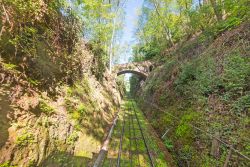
[0,49,120,166]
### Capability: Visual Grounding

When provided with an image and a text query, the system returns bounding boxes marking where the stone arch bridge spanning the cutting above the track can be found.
[112,61,154,81]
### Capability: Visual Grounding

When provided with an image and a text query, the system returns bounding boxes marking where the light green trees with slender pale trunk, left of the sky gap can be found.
[75,0,126,73]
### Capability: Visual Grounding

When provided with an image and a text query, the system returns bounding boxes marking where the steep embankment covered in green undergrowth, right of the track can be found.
[137,23,250,167]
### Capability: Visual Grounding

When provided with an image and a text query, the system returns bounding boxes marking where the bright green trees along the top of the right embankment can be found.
[134,0,250,59]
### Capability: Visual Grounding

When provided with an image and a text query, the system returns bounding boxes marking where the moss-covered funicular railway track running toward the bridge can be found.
[94,100,168,167]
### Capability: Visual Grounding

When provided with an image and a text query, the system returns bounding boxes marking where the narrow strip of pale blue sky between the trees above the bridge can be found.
[119,0,143,64]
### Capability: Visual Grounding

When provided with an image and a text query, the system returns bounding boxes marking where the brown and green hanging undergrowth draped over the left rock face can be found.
[0,0,82,92]
